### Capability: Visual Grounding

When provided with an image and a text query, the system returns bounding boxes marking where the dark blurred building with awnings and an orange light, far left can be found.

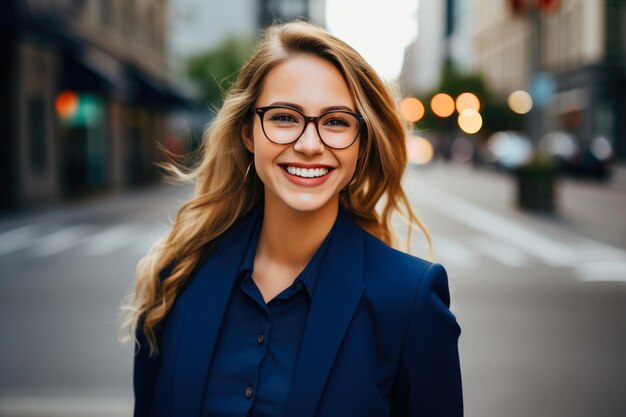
[0,0,180,209]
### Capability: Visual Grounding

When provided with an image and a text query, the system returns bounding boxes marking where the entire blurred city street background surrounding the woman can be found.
[0,0,626,417]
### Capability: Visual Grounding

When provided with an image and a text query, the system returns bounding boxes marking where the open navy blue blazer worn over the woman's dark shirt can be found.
[133,209,463,417]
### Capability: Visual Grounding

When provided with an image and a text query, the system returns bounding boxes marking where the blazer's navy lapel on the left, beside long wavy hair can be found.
[172,209,262,416]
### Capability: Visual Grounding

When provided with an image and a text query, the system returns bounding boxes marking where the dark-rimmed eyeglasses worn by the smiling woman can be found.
[255,106,364,149]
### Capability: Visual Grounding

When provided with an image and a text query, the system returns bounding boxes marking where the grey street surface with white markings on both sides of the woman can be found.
[0,163,626,417]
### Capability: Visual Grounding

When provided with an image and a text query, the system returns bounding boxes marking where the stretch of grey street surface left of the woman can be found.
[0,186,189,416]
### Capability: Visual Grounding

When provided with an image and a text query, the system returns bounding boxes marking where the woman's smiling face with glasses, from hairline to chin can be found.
[244,54,361,213]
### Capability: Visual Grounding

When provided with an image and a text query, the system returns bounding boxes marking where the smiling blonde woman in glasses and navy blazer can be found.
[123,18,463,417]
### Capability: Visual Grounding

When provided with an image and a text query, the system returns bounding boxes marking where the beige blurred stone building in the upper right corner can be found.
[473,0,626,160]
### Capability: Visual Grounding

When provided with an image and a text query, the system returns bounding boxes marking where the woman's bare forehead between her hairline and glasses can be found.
[257,54,355,114]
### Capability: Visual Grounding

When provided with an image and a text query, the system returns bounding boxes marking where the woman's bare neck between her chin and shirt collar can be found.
[256,194,339,268]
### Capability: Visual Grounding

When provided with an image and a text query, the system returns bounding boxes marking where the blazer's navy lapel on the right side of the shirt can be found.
[285,208,365,417]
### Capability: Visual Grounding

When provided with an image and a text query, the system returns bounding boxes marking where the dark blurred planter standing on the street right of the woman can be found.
[515,158,558,213]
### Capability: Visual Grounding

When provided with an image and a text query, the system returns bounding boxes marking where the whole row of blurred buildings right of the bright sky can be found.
[400,0,626,161]
